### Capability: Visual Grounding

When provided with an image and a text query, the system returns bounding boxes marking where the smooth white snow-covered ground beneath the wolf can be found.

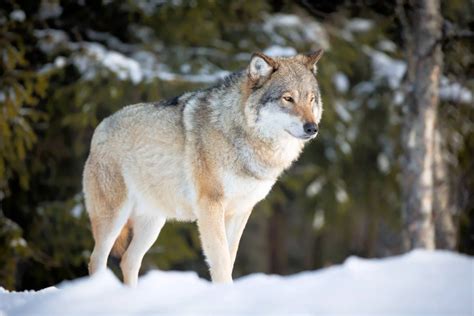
[0,250,474,316]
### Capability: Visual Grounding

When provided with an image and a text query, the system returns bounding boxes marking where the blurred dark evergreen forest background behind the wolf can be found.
[0,0,474,290]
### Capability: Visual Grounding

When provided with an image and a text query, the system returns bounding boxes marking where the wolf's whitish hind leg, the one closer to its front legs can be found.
[120,216,166,287]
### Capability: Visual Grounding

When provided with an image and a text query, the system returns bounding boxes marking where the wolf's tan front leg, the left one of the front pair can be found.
[197,202,232,283]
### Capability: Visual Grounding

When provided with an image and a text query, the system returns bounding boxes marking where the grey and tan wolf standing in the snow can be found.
[83,50,323,286]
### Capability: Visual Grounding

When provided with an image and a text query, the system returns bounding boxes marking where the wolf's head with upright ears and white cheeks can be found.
[245,50,323,140]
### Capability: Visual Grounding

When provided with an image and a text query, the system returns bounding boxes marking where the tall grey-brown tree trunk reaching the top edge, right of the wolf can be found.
[401,0,442,249]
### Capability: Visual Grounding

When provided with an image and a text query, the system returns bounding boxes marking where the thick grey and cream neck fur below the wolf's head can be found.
[194,71,304,180]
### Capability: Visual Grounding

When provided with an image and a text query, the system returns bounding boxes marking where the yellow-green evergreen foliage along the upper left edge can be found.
[0,10,48,195]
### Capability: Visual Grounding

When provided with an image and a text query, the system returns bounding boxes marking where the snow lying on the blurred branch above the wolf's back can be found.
[35,29,230,84]
